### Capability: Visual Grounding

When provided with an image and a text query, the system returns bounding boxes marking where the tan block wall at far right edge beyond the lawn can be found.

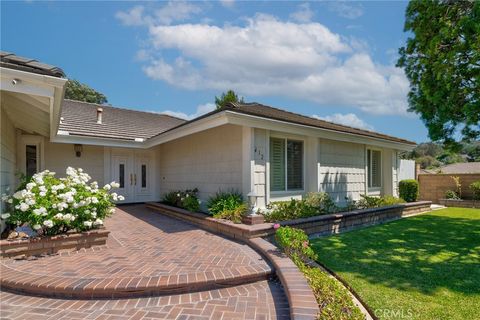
[418,173,480,203]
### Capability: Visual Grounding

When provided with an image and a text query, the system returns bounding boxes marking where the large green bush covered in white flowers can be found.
[1,167,124,235]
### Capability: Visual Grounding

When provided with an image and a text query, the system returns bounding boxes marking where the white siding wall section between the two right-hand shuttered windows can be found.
[316,139,365,203]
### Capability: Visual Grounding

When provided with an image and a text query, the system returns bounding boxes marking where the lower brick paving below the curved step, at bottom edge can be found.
[0,281,290,320]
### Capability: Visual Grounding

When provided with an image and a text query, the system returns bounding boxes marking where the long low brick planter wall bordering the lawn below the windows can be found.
[280,201,432,235]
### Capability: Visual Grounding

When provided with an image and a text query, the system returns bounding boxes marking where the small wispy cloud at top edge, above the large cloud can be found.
[115,1,202,26]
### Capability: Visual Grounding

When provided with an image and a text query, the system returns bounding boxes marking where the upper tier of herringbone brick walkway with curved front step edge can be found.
[0,205,272,298]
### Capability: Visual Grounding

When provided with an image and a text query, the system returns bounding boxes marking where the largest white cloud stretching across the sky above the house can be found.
[120,10,409,114]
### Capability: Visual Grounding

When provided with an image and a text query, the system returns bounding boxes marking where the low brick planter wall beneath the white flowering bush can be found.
[0,229,110,258]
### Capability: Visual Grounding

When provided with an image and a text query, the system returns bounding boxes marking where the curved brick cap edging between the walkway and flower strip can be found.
[245,238,320,320]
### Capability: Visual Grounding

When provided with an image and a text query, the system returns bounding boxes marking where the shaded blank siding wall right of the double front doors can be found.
[157,125,242,201]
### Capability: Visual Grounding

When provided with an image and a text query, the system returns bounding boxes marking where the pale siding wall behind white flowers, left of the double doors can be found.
[44,142,105,186]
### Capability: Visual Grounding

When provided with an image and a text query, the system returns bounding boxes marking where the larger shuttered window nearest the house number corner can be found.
[270,138,303,191]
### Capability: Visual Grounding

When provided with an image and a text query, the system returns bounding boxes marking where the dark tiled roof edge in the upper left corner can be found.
[0,51,65,78]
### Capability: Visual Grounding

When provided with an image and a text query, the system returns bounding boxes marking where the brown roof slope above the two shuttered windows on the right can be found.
[225,102,416,145]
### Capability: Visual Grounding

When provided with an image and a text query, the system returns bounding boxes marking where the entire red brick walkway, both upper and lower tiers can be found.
[0,205,289,319]
